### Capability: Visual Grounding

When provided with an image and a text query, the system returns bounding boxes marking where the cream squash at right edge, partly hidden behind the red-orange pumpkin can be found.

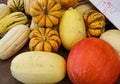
[100,29,120,59]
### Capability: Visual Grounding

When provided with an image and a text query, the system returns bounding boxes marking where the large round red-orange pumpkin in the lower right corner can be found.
[67,37,120,84]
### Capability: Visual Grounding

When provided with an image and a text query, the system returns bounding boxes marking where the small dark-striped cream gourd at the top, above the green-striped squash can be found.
[7,0,24,11]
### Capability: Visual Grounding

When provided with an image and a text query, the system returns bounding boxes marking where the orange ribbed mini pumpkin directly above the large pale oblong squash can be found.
[29,28,61,52]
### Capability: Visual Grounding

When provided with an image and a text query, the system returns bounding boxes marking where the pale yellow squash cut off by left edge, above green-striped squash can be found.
[0,4,11,20]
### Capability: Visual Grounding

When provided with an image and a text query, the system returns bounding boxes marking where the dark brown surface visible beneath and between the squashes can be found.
[0,0,120,84]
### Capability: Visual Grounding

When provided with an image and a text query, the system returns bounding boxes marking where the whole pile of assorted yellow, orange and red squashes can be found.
[0,0,120,84]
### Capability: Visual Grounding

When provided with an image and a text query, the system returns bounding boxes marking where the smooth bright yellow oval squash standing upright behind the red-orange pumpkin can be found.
[59,8,86,50]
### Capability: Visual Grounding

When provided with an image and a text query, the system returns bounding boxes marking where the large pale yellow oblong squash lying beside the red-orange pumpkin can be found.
[10,51,66,84]
